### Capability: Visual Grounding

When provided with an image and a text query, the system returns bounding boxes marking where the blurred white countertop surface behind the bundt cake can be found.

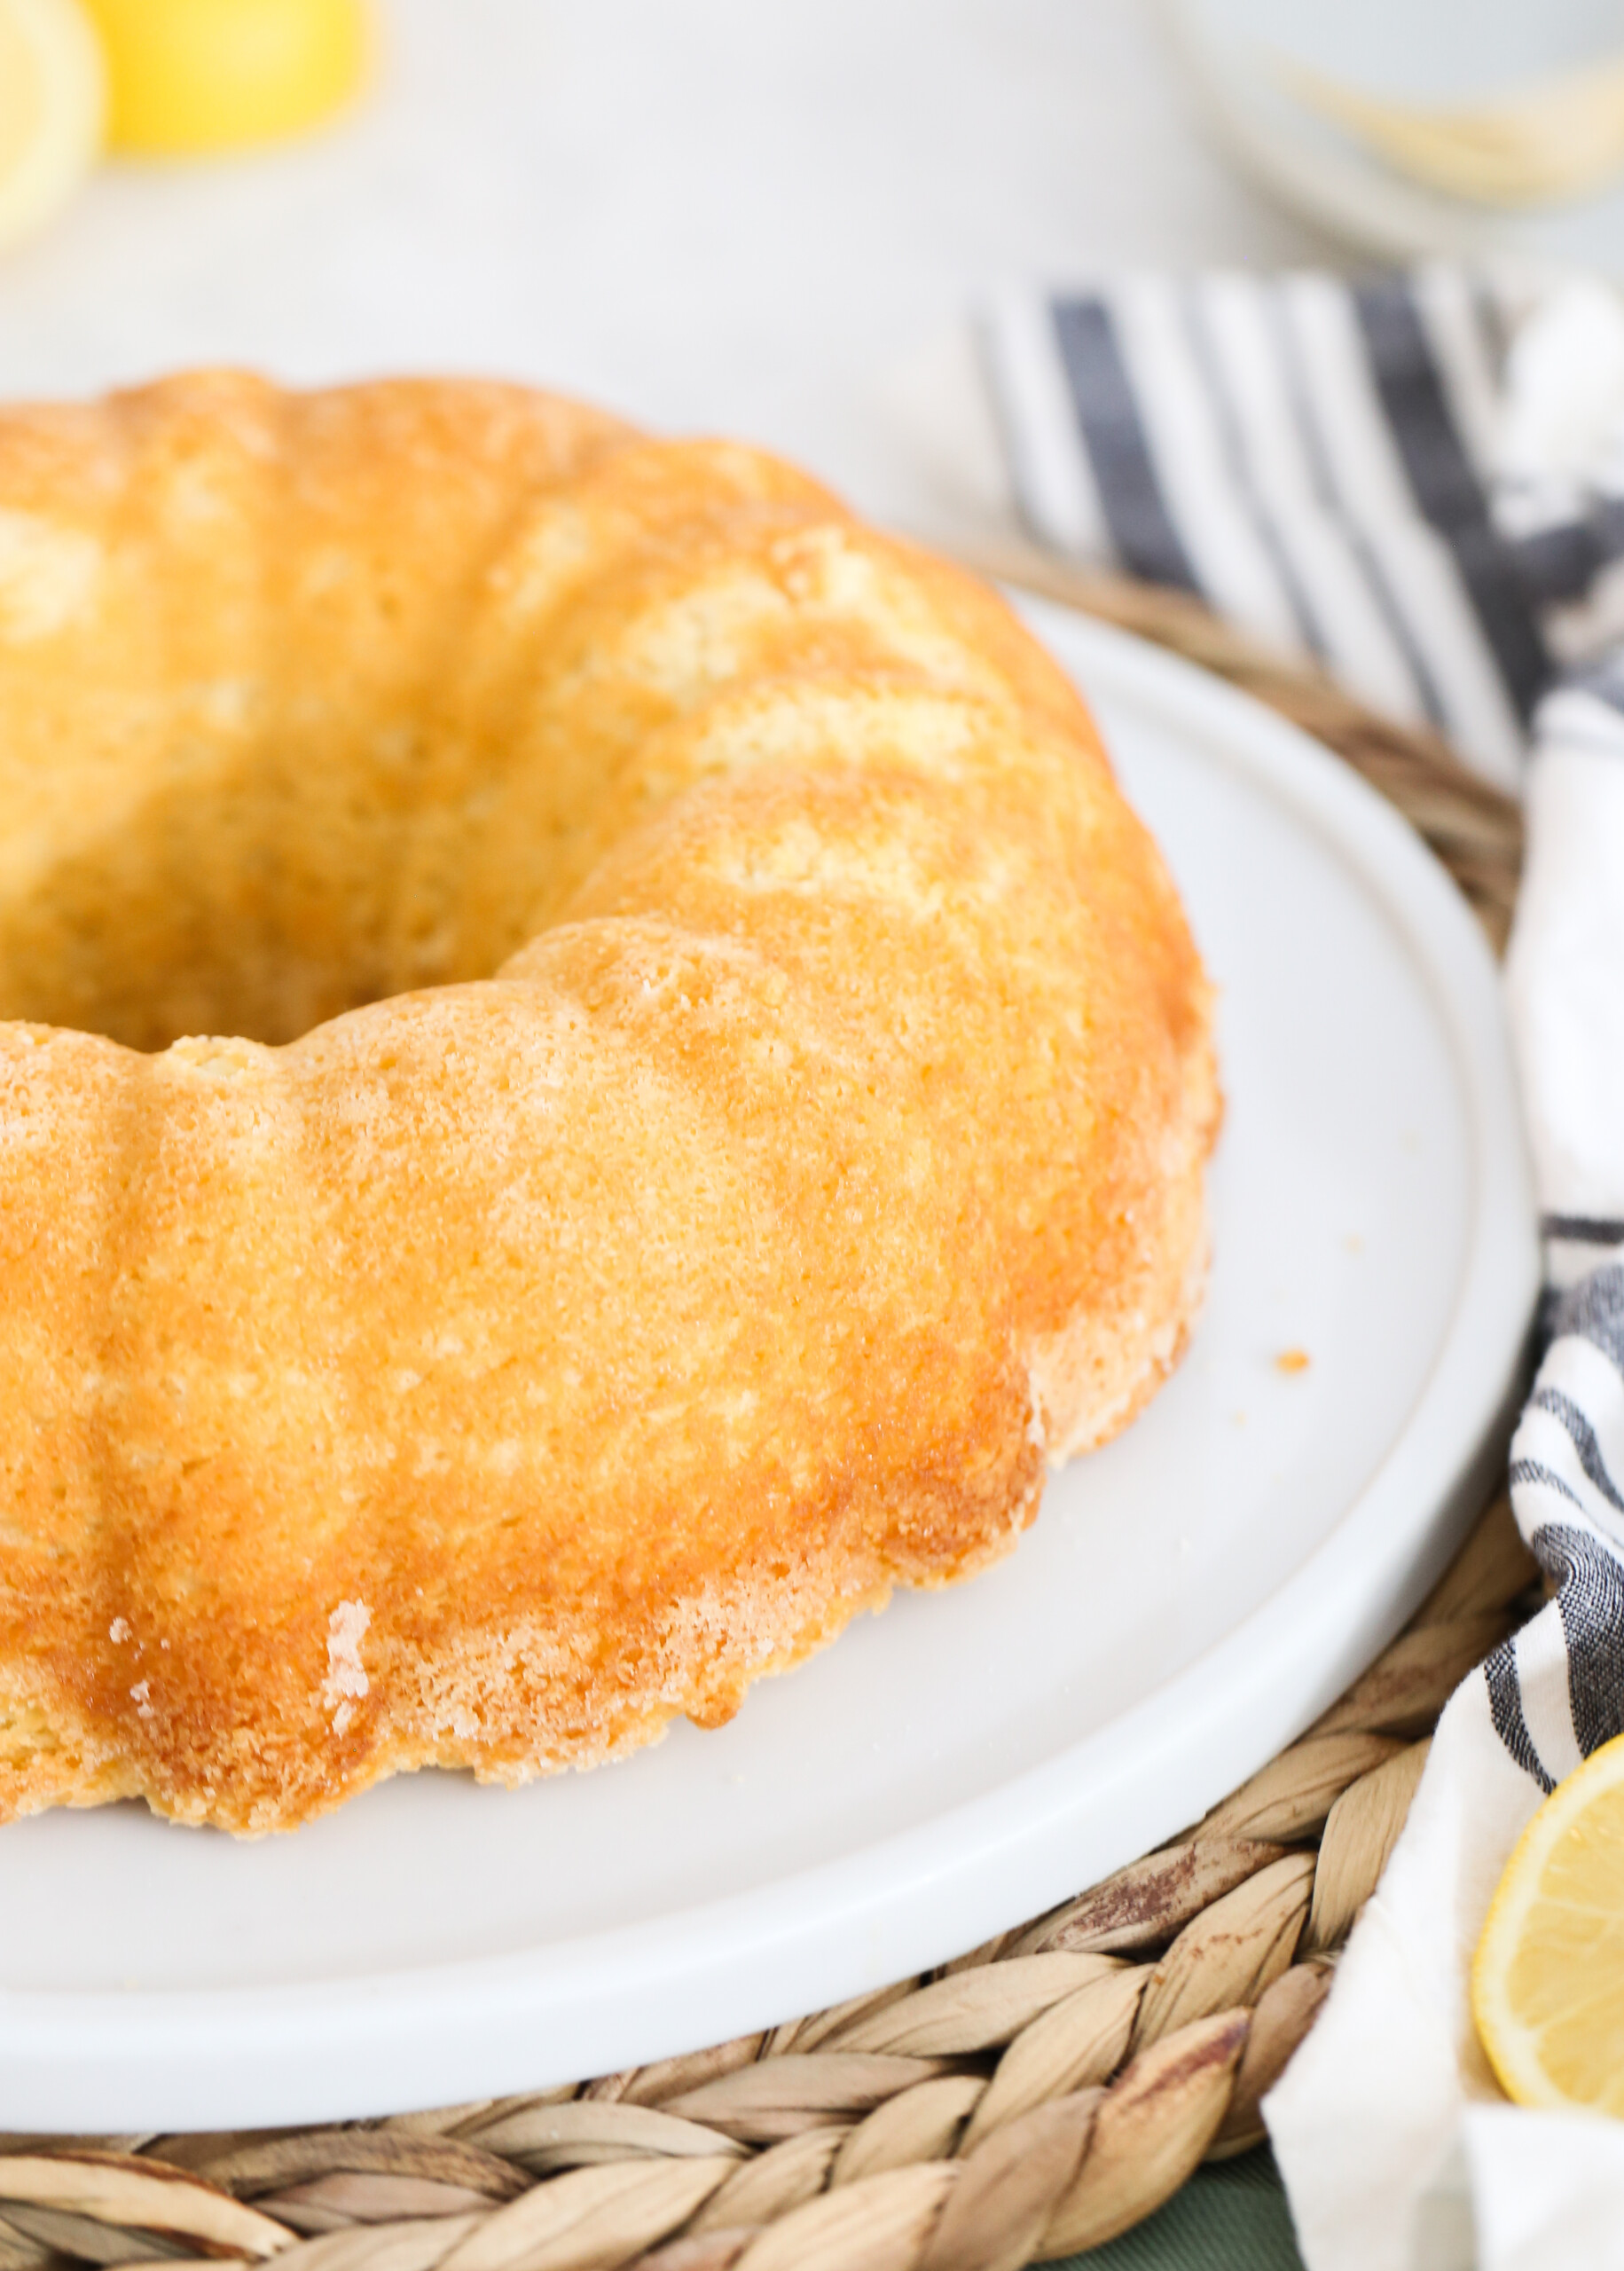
[0,0,1327,538]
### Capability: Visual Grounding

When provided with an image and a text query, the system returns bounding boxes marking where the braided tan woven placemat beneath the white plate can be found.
[0,568,1538,2271]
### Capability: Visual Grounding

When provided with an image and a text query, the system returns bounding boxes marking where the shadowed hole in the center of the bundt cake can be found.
[0,761,556,1049]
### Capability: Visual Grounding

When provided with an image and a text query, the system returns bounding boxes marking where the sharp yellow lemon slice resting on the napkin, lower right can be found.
[1471,1735,1624,2114]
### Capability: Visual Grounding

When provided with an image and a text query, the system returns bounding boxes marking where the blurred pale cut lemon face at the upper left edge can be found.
[0,0,105,245]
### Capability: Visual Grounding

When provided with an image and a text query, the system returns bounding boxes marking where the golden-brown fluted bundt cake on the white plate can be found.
[0,373,1218,1833]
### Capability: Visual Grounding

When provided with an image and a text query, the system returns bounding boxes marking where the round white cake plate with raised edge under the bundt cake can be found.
[0,607,1538,2130]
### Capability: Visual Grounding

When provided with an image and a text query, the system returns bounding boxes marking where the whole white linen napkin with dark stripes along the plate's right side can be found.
[984,268,1624,2271]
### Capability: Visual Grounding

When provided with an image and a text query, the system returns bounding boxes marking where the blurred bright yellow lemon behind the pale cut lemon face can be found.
[86,0,368,154]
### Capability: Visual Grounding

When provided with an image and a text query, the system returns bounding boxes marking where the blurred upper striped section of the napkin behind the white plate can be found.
[984,268,1624,786]
